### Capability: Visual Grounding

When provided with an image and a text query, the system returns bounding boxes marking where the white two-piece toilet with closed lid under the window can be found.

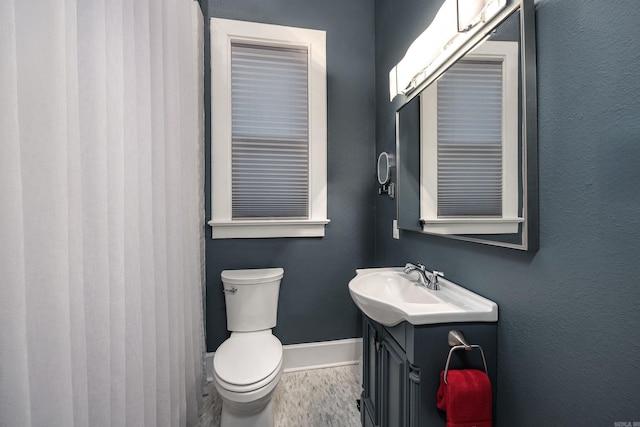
[213,268,284,427]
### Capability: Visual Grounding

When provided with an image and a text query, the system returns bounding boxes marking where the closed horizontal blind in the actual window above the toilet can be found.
[231,43,309,219]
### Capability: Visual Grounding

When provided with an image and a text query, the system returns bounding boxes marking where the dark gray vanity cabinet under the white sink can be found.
[361,315,496,427]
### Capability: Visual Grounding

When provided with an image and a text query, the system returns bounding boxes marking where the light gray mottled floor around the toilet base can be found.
[200,365,361,427]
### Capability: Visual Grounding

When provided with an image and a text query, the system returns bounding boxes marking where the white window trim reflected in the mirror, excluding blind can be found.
[420,41,524,234]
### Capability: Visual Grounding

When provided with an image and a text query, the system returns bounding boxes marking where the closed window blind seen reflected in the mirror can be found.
[437,61,503,217]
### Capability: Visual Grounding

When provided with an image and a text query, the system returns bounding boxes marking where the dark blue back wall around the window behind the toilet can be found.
[203,0,375,351]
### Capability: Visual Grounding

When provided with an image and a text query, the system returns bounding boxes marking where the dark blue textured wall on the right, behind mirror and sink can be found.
[376,0,640,427]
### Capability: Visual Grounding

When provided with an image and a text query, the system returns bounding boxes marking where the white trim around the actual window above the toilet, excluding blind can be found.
[208,18,329,239]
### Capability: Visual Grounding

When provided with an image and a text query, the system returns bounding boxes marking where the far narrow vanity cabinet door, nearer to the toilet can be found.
[360,316,380,427]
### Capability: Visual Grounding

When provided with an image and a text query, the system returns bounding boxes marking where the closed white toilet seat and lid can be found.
[213,330,282,393]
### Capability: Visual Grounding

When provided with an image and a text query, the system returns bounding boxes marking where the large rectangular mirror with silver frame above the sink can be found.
[396,0,538,250]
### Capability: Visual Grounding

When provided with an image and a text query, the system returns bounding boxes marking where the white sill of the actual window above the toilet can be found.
[208,219,329,239]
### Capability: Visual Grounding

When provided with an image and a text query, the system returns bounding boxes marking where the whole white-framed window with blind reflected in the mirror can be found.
[420,41,523,234]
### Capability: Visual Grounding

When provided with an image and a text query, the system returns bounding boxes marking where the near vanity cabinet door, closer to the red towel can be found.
[380,335,408,427]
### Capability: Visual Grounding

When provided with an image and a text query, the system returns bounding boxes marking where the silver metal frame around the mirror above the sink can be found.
[396,0,539,251]
